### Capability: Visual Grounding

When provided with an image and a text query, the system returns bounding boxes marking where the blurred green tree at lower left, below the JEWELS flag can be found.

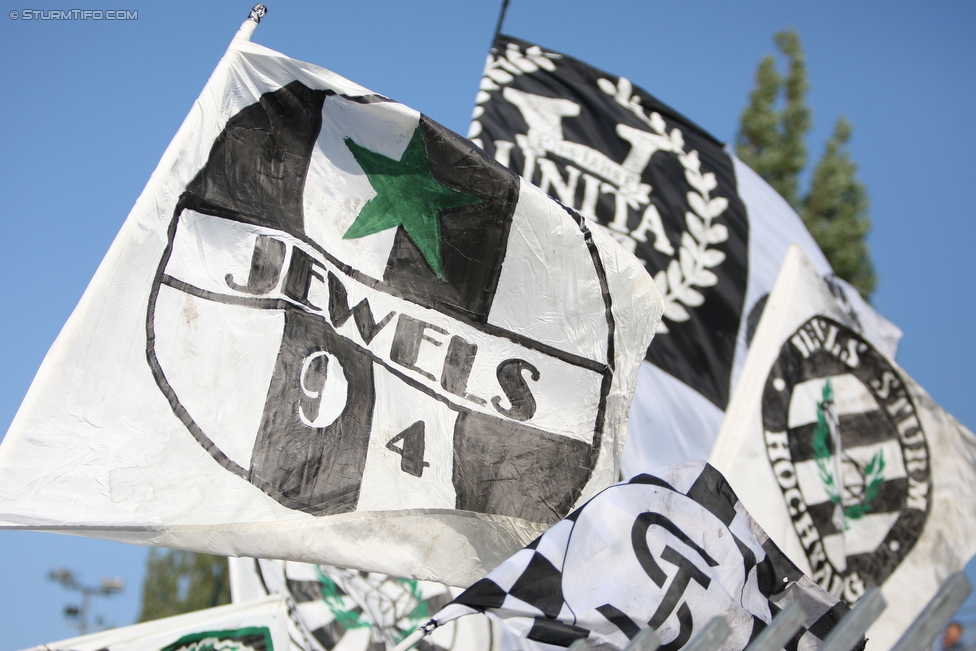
[139,547,230,622]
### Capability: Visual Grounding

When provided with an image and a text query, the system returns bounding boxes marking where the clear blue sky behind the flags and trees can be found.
[0,0,976,651]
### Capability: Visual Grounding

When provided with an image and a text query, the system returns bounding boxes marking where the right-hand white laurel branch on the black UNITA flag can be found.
[597,77,729,333]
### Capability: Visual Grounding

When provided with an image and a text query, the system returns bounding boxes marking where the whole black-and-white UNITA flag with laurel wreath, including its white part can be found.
[468,36,901,476]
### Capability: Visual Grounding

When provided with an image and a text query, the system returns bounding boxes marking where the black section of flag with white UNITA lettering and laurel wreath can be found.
[470,36,749,409]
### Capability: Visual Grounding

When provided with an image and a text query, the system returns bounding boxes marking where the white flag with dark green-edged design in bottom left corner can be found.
[25,595,288,651]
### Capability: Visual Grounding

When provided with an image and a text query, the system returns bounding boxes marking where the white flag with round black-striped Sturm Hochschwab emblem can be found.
[712,248,976,649]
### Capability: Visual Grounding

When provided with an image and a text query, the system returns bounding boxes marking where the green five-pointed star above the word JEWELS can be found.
[342,127,481,278]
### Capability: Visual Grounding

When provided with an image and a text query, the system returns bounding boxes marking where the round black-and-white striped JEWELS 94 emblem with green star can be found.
[146,81,615,523]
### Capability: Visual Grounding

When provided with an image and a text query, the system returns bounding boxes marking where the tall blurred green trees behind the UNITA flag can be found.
[736,30,877,298]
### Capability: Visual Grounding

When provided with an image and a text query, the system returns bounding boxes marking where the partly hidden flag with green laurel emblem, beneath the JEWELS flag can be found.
[228,558,504,651]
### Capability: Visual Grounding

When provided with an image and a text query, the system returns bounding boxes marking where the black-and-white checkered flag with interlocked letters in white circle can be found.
[426,461,848,650]
